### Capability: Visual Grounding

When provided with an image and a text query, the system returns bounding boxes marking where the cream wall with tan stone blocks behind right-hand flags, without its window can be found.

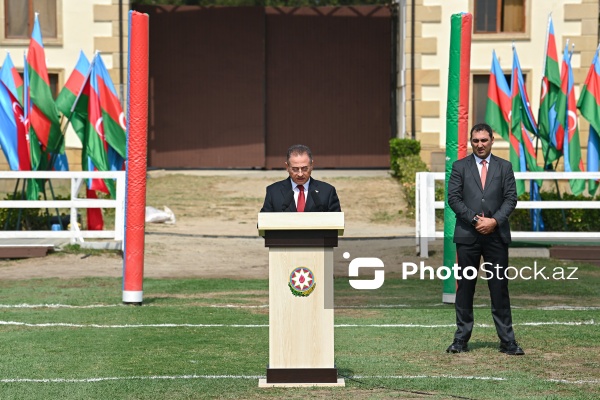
[405,0,599,170]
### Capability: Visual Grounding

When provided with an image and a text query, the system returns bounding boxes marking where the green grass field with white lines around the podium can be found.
[0,259,600,399]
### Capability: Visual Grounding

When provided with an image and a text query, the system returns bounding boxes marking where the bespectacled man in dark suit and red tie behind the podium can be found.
[260,144,341,212]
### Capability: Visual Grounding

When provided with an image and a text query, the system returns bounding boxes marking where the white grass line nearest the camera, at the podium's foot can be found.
[0,375,600,384]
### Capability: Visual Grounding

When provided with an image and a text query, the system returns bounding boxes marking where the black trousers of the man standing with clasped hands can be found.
[454,235,515,342]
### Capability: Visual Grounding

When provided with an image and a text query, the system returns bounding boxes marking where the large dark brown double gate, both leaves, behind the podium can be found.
[137,6,393,168]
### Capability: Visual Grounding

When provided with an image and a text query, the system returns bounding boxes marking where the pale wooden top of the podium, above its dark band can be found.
[258,212,344,236]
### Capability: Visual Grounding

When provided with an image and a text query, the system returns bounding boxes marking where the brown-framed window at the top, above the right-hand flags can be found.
[474,0,525,33]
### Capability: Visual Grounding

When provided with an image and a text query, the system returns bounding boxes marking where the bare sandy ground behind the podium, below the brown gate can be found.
[0,171,440,279]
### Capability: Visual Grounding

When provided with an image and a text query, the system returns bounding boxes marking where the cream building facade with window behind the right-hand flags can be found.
[399,0,599,171]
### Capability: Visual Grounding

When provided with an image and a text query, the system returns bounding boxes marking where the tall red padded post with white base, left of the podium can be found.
[123,11,149,305]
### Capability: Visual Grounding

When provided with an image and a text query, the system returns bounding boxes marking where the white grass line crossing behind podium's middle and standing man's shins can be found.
[0,320,597,329]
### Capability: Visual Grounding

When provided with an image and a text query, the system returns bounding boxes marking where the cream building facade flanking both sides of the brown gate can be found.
[0,0,599,171]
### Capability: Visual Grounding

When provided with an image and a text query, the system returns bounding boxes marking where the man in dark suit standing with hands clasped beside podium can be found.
[446,124,525,355]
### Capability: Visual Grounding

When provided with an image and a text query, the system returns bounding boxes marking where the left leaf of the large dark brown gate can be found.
[139,6,265,168]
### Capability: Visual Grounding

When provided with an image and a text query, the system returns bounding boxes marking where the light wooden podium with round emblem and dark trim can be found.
[258,212,345,387]
